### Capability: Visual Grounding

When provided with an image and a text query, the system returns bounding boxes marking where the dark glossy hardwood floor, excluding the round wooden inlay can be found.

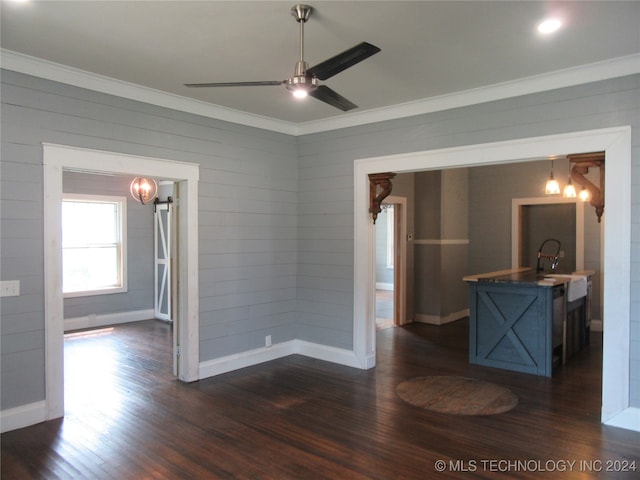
[1,320,640,479]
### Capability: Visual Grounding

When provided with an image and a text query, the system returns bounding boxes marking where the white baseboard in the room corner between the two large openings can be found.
[199,340,362,379]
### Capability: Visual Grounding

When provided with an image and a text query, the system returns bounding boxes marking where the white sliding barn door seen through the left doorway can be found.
[153,203,172,321]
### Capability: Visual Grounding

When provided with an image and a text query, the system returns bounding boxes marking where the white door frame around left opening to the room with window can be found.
[43,143,200,420]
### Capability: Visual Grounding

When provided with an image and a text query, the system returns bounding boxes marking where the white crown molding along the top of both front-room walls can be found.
[0,49,640,136]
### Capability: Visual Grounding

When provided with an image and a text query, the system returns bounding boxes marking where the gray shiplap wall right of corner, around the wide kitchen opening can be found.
[298,75,640,406]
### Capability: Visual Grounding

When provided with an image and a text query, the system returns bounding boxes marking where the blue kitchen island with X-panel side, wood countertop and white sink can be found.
[464,268,593,377]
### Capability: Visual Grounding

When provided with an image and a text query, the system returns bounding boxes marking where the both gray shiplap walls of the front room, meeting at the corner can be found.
[0,71,640,409]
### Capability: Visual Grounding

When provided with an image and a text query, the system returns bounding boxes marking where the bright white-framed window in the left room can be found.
[62,194,127,297]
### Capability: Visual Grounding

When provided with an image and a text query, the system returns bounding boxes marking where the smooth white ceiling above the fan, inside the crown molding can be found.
[0,0,640,133]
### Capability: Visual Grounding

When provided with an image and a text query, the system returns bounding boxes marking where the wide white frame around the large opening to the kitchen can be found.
[353,126,640,430]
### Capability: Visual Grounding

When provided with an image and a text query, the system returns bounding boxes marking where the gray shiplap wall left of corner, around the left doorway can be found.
[0,70,298,410]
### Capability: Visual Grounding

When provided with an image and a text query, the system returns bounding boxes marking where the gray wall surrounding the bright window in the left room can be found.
[62,172,153,318]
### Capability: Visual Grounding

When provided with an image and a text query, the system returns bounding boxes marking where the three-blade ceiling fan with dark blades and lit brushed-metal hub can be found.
[185,5,380,112]
